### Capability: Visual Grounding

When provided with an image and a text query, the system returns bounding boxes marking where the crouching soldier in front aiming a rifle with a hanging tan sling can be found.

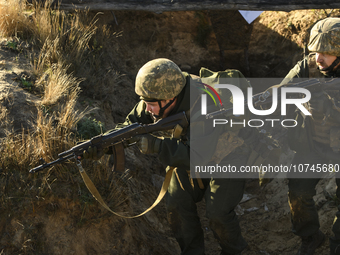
[84,59,272,255]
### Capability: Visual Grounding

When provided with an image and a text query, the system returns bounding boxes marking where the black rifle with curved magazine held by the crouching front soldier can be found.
[30,112,189,173]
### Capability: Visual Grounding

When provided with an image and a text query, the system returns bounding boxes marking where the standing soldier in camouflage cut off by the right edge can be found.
[281,18,340,255]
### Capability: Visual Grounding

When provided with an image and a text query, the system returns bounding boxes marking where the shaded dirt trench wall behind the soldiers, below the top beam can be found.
[92,11,304,78]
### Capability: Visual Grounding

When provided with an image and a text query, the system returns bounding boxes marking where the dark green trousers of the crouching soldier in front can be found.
[166,170,247,255]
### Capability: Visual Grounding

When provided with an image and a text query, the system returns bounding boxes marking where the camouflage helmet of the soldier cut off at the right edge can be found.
[308,18,340,57]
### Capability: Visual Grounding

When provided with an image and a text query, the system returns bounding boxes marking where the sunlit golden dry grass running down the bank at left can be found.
[0,0,96,175]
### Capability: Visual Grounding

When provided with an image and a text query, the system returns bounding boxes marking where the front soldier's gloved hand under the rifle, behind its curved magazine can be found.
[129,134,163,154]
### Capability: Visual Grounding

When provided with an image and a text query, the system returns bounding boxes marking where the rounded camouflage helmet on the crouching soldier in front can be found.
[135,58,185,102]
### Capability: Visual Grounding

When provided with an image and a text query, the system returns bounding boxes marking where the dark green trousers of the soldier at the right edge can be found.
[288,152,340,246]
